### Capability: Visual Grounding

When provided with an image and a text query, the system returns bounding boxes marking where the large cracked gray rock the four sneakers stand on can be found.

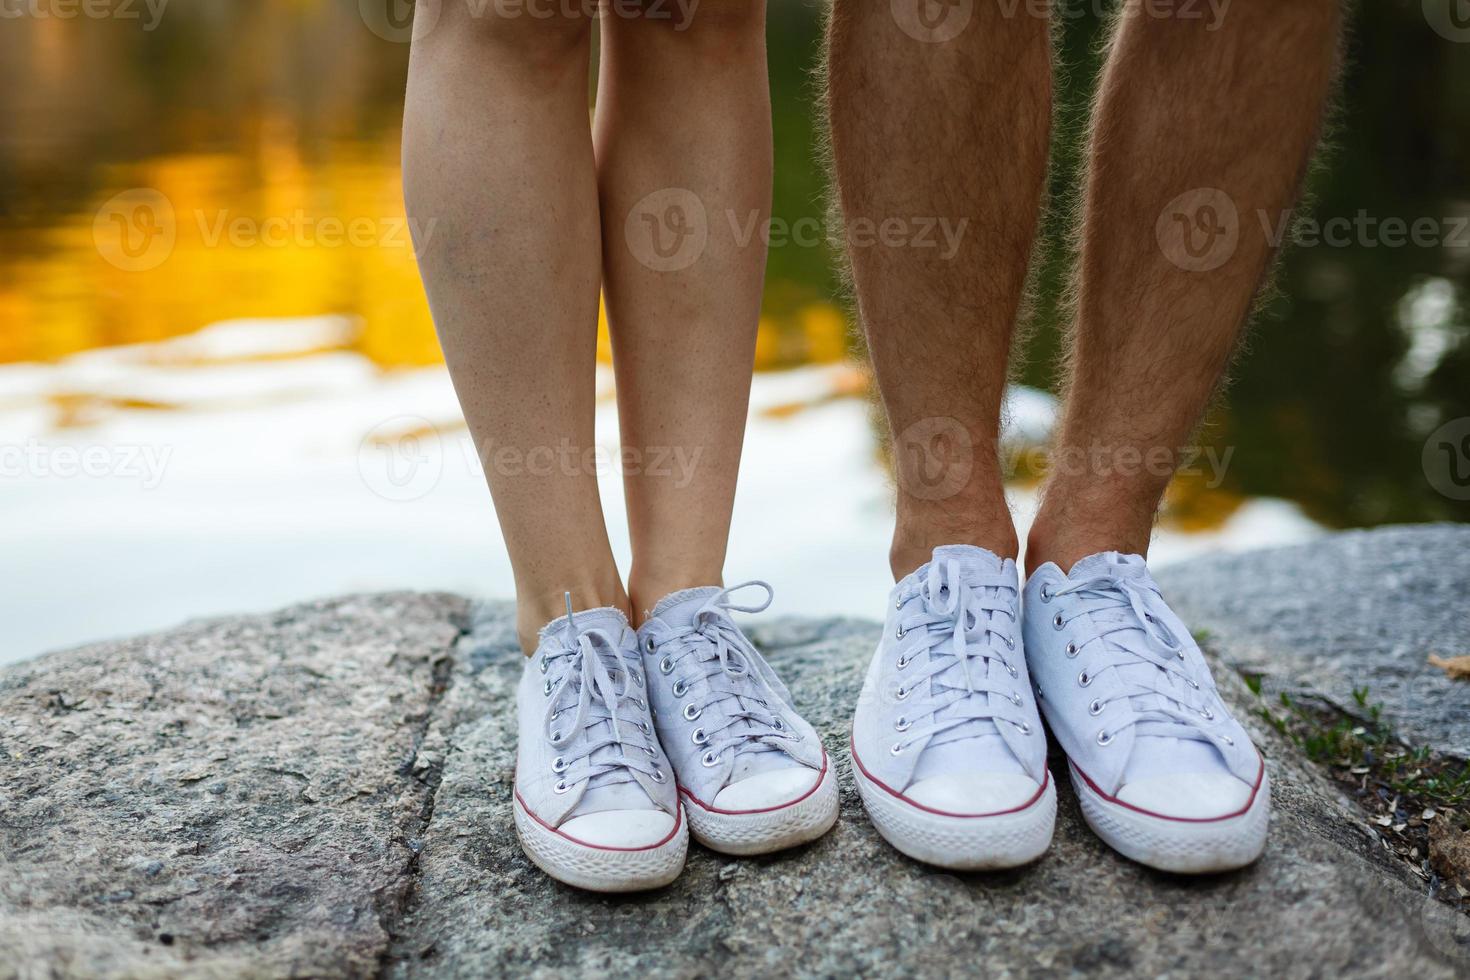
[0,532,1470,979]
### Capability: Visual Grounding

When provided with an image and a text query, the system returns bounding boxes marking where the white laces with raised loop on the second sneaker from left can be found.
[659,580,798,765]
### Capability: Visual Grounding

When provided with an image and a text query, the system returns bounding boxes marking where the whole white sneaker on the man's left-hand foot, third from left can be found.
[853,545,1057,870]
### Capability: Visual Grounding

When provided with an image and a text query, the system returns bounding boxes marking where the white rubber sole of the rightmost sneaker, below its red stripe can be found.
[1070,765,1272,874]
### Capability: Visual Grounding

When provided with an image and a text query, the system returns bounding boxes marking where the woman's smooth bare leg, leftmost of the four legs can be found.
[403,3,626,651]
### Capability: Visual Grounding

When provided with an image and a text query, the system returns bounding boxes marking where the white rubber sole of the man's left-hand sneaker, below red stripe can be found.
[853,754,1057,871]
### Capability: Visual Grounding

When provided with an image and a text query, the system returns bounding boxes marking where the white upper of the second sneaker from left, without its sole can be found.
[638,582,826,811]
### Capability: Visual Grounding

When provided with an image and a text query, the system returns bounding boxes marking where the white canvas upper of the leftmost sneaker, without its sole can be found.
[516,608,679,848]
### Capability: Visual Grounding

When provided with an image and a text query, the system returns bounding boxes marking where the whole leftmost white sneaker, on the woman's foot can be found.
[515,601,689,892]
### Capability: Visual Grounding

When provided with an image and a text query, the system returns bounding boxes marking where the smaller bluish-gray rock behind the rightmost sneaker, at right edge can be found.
[1158,525,1470,758]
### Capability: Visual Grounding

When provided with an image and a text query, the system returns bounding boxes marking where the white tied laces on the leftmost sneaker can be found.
[542,597,663,792]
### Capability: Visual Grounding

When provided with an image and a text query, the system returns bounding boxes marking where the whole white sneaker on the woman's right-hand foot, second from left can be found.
[638,582,838,854]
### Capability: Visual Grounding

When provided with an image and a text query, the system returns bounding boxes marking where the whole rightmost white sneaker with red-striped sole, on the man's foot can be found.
[1023,551,1272,873]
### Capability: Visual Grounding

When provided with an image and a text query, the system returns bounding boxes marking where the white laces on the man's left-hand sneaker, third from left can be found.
[892,558,1030,755]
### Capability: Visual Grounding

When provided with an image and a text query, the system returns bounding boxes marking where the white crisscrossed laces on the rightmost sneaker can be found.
[1051,573,1233,745]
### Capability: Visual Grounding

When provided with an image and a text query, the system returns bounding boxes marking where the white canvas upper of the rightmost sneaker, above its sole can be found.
[1025,551,1263,820]
